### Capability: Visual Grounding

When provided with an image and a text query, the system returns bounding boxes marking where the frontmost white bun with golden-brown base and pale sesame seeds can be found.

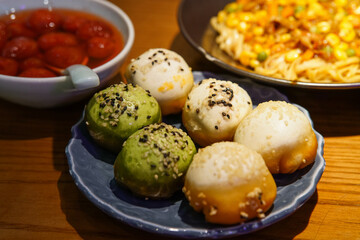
[183,142,276,224]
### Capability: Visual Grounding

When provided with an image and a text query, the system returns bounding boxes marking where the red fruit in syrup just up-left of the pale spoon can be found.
[45,46,85,68]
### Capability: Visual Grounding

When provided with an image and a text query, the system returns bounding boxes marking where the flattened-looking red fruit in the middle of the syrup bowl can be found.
[38,32,78,51]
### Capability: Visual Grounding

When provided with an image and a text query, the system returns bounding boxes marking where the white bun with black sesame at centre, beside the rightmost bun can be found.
[182,78,252,147]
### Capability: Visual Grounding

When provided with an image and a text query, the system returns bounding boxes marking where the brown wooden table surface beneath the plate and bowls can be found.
[0,0,360,240]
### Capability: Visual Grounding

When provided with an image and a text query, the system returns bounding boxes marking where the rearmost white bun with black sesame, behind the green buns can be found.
[125,48,194,115]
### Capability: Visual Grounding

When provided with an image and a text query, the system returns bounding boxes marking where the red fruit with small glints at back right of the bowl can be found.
[76,20,112,40]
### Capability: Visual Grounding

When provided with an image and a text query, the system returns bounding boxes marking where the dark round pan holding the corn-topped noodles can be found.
[178,0,360,90]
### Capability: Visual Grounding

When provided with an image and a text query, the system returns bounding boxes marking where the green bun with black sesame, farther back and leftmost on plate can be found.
[85,83,161,153]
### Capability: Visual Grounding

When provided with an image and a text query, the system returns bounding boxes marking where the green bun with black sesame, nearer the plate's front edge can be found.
[114,123,196,198]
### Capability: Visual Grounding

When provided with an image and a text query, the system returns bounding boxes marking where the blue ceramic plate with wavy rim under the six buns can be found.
[66,72,325,238]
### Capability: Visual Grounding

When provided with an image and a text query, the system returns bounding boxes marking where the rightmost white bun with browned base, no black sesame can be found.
[234,101,317,173]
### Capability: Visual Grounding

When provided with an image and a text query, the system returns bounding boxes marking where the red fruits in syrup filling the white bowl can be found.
[0,9,122,77]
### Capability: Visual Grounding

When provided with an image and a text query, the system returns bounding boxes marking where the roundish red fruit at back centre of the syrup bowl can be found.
[27,9,62,33]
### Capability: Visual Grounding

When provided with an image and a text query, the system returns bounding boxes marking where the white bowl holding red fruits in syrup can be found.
[0,0,135,108]
